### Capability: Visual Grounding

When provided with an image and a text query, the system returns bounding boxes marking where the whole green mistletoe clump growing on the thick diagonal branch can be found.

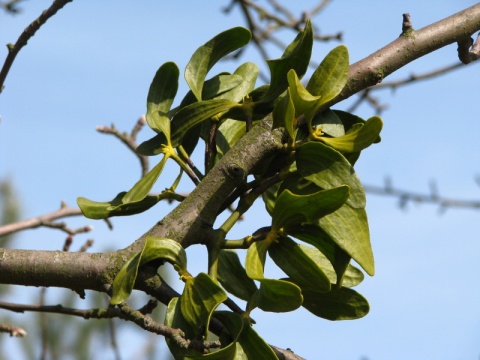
[78,22,382,359]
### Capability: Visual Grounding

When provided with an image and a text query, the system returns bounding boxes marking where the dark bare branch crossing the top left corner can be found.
[0,0,72,93]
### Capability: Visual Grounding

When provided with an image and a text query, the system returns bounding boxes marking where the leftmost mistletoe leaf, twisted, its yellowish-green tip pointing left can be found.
[77,191,160,219]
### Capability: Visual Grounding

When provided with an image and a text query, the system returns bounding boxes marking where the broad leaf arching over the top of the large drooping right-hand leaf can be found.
[295,142,366,208]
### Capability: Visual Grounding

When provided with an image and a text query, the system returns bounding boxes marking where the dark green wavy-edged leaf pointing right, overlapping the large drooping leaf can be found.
[272,186,349,232]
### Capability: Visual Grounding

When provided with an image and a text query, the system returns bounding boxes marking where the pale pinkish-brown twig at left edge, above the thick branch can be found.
[0,203,82,236]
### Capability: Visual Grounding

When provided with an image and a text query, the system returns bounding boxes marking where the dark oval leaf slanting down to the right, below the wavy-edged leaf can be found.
[268,236,330,291]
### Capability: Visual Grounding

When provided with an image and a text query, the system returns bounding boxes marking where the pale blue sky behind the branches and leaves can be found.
[0,0,480,360]
